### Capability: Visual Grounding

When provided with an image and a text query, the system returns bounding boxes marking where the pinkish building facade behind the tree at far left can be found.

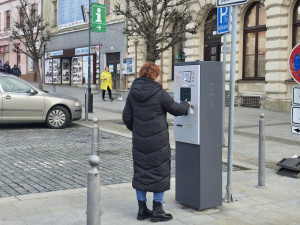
[0,0,41,81]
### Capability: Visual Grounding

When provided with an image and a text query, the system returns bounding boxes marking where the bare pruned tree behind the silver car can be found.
[10,0,51,89]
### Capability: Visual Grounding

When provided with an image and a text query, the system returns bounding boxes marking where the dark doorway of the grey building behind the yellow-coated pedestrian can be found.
[106,52,120,89]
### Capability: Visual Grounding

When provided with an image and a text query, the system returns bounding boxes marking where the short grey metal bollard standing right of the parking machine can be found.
[258,113,265,187]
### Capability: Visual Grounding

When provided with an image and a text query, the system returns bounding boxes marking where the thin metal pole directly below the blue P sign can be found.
[222,34,227,147]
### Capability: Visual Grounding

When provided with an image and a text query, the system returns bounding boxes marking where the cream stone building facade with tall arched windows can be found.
[129,0,300,111]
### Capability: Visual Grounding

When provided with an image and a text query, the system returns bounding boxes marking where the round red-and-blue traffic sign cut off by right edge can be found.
[289,43,300,84]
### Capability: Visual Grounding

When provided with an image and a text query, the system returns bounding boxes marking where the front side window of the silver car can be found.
[0,76,32,93]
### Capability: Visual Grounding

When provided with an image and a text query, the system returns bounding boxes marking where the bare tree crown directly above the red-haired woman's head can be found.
[114,0,200,62]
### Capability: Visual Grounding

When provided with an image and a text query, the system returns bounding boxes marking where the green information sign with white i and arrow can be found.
[91,3,106,32]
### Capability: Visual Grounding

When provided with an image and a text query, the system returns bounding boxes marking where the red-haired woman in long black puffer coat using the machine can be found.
[122,62,190,222]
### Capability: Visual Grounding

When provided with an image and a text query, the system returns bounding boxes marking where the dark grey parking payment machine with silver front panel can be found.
[174,61,222,210]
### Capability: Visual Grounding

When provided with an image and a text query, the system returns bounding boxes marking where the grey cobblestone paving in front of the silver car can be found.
[0,121,239,197]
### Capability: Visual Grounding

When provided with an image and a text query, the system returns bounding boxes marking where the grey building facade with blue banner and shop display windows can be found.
[43,0,125,88]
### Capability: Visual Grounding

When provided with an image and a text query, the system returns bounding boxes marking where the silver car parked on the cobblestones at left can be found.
[0,72,82,129]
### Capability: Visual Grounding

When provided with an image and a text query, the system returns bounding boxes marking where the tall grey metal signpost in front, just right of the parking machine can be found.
[224,5,237,202]
